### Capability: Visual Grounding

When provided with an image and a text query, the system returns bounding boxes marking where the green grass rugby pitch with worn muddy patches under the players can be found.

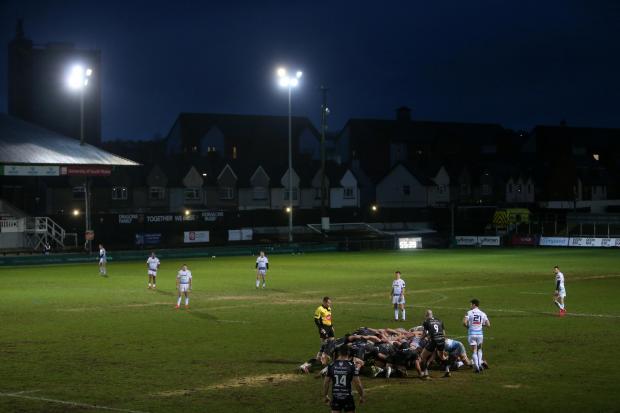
[0,249,620,413]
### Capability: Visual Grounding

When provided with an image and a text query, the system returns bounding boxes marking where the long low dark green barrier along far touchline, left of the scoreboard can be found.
[0,243,339,266]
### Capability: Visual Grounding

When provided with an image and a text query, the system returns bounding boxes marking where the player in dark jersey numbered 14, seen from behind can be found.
[323,346,364,413]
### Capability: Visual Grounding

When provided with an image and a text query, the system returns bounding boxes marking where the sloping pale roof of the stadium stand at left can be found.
[0,113,140,166]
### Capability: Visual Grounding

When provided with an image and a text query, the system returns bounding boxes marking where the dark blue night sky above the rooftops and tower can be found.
[0,0,620,140]
